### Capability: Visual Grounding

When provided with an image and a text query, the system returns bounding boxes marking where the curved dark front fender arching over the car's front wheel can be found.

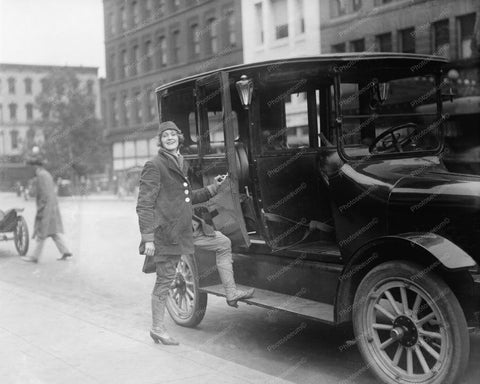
[335,233,476,323]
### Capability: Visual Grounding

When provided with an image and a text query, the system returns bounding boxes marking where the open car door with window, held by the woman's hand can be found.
[195,72,250,247]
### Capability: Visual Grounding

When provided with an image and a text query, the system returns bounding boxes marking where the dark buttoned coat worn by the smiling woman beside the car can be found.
[137,150,213,268]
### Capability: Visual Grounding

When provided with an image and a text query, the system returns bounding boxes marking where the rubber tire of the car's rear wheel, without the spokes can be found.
[167,255,208,328]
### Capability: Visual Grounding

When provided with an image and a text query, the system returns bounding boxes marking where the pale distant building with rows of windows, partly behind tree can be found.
[0,64,101,162]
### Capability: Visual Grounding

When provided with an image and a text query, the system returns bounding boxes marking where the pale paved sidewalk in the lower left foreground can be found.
[0,281,290,384]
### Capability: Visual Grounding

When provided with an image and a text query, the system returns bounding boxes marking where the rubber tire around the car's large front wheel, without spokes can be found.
[353,261,470,384]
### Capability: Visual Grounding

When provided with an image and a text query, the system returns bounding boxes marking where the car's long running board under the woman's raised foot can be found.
[200,284,334,325]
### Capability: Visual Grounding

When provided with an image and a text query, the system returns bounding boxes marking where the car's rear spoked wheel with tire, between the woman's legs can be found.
[167,255,207,327]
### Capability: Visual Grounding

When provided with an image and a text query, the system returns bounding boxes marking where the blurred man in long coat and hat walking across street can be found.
[22,156,72,263]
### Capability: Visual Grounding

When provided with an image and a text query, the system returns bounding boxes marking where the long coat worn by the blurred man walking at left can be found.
[33,168,63,239]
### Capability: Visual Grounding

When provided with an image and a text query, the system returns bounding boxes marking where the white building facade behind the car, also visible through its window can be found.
[242,0,321,146]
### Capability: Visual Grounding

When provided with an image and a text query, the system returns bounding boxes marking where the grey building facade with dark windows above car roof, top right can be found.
[321,0,480,60]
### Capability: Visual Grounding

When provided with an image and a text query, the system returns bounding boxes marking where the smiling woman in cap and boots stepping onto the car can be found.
[136,121,253,345]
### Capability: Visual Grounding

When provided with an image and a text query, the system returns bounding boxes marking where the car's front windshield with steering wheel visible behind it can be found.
[339,76,445,158]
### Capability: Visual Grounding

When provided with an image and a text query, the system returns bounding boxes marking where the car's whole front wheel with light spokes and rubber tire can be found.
[353,262,469,384]
